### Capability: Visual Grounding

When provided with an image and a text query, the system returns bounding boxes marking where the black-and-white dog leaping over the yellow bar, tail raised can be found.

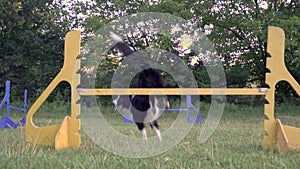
[110,33,170,140]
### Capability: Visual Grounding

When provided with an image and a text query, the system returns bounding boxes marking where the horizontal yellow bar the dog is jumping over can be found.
[77,88,268,96]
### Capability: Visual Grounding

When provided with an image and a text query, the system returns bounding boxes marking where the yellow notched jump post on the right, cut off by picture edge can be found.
[263,26,300,152]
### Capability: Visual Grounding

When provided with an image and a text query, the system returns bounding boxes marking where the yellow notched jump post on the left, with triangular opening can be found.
[26,31,80,149]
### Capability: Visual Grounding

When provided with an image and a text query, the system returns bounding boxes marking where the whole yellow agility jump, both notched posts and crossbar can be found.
[26,27,300,152]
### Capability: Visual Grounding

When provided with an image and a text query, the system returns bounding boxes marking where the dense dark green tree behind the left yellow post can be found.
[0,0,78,98]
